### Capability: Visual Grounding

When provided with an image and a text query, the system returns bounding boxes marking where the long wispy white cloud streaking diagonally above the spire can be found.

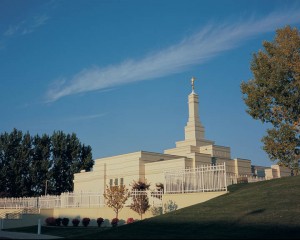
[47,9,300,102]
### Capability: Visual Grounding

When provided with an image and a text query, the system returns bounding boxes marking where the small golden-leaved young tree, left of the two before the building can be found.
[104,185,129,218]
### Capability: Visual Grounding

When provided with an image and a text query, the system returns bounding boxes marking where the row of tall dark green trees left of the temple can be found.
[0,129,93,197]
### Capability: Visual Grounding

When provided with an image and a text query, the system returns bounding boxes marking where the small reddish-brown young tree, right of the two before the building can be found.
[130,181,150,219]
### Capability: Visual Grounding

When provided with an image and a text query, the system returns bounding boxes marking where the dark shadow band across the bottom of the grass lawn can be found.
[10,220,300,239]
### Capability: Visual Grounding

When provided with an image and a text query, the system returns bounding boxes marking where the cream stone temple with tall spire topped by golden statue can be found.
[73,77,290,192]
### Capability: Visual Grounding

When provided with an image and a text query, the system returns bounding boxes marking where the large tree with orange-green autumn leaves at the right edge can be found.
[241,26,300,173]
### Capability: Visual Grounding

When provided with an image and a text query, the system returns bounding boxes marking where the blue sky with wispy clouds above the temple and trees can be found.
[0,0,300,166]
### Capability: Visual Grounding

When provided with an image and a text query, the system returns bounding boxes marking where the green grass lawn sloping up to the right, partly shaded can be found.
[4,176,300,239]
